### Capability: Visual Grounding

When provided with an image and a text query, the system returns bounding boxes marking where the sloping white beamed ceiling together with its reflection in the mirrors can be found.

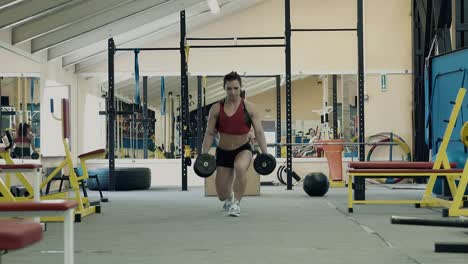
[0,0,314,108]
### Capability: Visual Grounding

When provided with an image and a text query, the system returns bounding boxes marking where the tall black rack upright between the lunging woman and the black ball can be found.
[284,0,292,190]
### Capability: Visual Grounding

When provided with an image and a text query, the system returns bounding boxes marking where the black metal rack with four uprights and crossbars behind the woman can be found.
[106,0,365,193]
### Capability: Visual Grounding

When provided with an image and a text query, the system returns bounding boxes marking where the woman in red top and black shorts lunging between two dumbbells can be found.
[202,72,267,216]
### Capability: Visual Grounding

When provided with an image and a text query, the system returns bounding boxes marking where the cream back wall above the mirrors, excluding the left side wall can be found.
[81,0,412,150]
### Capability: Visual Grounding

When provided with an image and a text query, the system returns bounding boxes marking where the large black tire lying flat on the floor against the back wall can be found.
[87,168,151,191]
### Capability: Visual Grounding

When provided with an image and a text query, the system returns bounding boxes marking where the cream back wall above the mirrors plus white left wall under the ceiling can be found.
[0,0,412,182]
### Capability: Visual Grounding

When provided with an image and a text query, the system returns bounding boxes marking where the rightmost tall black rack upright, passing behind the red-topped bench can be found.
[354,0,366,200]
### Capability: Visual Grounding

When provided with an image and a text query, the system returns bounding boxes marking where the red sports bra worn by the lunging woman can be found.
[216,99,252,135]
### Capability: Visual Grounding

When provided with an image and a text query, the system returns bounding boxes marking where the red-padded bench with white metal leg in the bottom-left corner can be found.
[0,200,78,264]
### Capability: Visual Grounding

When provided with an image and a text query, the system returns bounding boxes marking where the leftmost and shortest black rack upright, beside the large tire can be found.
[107,38,115,191]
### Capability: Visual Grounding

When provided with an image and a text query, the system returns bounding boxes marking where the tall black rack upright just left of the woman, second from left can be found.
[180,10,187,191]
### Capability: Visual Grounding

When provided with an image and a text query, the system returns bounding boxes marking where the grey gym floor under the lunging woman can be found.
[3,184,468,264]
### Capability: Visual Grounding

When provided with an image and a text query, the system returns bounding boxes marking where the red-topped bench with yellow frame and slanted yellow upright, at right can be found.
[348,88,468,216]
